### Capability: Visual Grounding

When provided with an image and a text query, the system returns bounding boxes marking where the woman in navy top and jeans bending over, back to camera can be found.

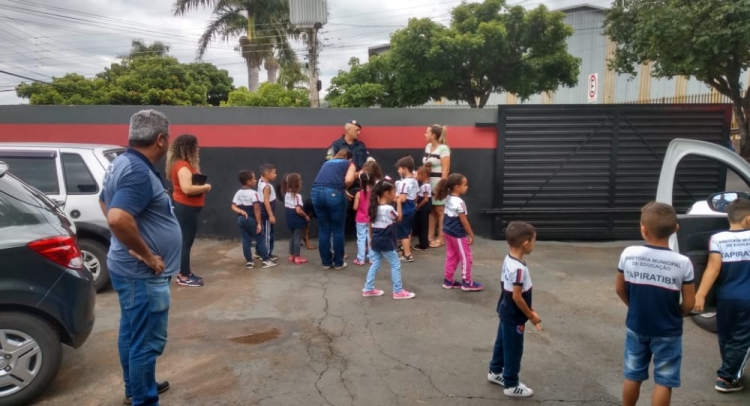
[310,149,356,271]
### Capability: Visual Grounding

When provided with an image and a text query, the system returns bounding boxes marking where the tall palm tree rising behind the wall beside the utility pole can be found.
[174,0,297,91]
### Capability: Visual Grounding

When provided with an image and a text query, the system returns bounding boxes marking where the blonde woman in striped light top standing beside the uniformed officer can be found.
[422,124,451,248]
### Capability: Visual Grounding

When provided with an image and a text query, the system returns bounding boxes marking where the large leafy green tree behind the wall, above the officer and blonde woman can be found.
[327,0,581,108]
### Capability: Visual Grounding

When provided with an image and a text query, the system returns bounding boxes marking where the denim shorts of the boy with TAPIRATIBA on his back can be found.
[625,329,682,388]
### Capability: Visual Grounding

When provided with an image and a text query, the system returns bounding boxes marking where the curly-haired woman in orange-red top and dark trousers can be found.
[167,134,211,287]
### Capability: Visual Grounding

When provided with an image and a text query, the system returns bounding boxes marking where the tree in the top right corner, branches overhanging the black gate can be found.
[604,0,750,157]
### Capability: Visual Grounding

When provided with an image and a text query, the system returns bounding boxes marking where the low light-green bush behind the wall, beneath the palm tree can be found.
[221,83,310,107]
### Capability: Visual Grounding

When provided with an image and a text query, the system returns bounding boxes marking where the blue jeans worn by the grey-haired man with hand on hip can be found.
[109,273,171,406]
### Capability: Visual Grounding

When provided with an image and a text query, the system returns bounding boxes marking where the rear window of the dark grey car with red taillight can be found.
[0,174,60,228]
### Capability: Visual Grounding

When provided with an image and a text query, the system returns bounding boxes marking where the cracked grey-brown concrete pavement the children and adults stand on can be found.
[36,240,750,406]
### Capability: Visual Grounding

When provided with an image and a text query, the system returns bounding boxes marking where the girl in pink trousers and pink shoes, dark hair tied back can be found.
[435,173,484,292]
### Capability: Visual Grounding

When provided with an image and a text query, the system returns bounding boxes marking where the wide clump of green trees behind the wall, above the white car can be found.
[16,41,234,106]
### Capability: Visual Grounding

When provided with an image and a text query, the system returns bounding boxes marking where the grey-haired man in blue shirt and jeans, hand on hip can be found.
[100,110,181,406]
